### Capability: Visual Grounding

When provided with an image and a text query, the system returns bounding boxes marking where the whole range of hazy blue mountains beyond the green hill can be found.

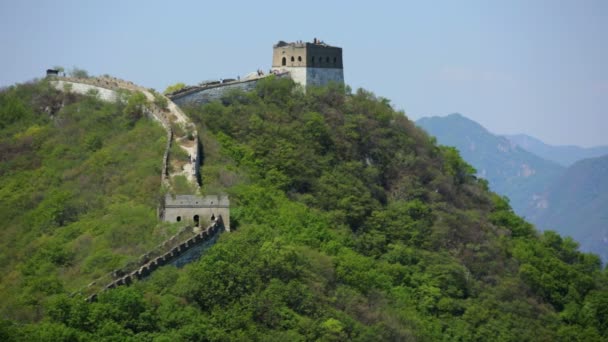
[416,114,608,262]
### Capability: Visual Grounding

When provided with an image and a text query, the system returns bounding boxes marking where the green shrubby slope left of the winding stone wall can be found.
[0,82,176,321]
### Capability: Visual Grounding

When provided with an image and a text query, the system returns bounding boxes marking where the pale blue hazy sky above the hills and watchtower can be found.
[0,0,608,146]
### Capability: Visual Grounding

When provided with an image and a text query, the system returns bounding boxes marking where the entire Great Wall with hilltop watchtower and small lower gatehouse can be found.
[47,38,344,301]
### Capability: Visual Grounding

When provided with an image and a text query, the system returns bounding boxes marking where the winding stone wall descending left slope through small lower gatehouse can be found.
[50,76,230,301]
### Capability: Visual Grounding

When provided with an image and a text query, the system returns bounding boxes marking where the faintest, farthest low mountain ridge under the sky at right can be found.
[504,134,608,166]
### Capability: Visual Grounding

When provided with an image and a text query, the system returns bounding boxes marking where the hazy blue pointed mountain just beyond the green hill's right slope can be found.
[416,114,564,215]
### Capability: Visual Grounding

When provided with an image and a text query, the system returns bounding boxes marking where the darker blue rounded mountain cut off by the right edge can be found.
[527,156,608,261]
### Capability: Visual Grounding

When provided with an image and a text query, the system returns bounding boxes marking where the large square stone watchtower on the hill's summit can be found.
[272,38,344,87]
